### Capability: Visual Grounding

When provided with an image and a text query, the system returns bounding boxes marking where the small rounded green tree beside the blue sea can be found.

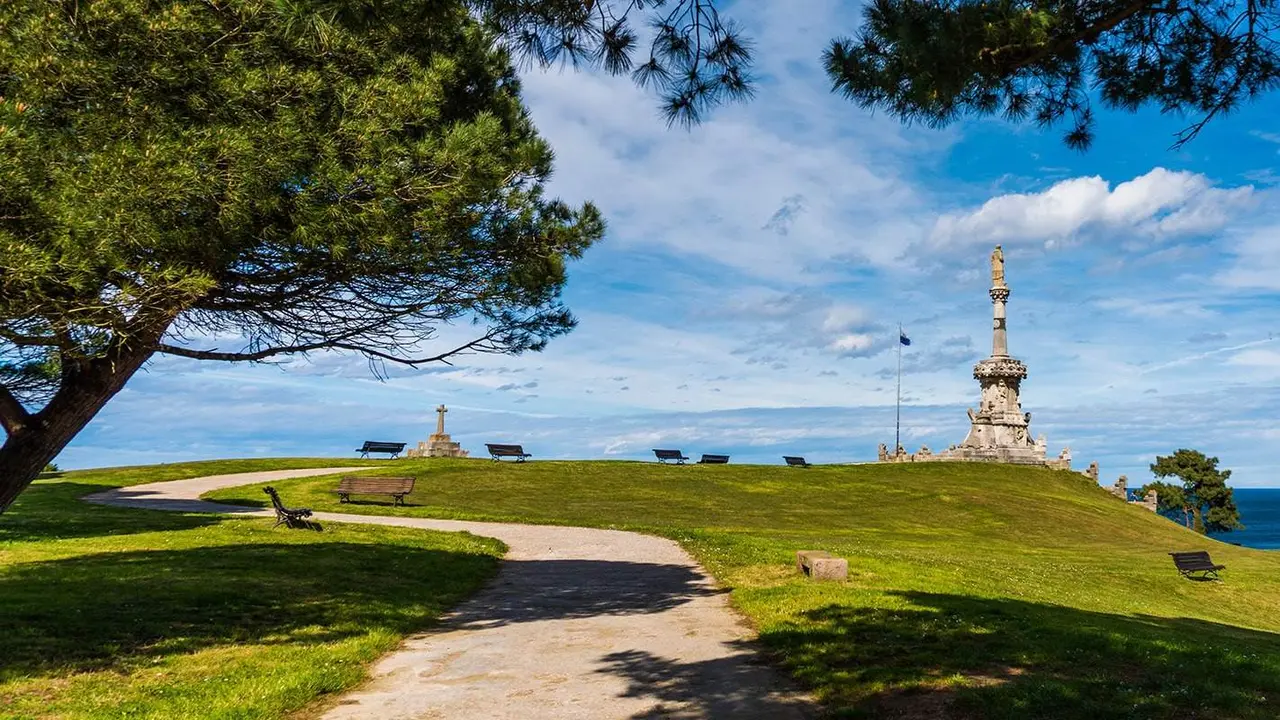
[1142,448,1244,533]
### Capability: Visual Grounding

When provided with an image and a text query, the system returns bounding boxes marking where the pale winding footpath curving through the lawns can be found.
[84,468,815,720]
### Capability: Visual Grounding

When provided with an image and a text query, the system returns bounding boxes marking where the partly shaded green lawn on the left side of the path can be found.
[0,460,503,720]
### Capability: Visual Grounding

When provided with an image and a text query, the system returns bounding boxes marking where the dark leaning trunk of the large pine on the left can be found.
[0,343,154,514]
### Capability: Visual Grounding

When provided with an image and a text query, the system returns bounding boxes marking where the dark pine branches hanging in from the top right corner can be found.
[824,0,1280,150]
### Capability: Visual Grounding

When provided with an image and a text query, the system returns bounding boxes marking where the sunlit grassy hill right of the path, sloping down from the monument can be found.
[211,460,1280,720]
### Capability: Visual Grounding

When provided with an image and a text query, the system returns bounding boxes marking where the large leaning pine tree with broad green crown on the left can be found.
[0,0,604,497]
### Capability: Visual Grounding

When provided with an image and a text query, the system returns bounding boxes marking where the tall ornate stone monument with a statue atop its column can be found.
[882,245,1071,470]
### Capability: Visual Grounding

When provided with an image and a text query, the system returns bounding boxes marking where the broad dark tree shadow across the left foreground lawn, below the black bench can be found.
[0,538,498,680]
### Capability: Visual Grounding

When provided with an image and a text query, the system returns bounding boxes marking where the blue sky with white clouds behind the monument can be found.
[59,1,1280,486]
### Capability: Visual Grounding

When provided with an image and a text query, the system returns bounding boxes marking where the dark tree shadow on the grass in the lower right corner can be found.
[762,592,1280,720]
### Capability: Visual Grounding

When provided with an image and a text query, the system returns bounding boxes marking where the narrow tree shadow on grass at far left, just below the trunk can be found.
[0,482,221,542]
